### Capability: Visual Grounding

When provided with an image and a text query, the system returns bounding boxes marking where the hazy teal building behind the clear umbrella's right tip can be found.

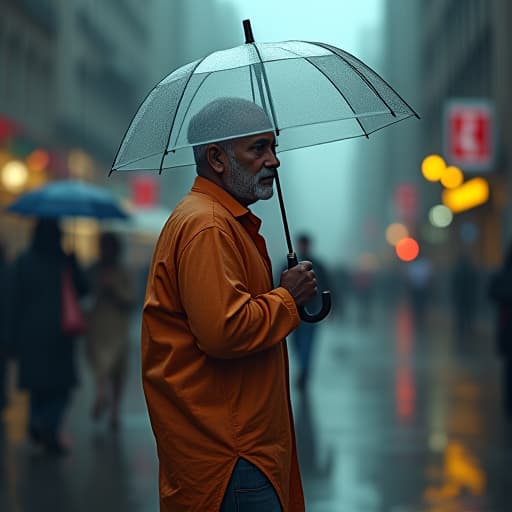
[352,0,422,280]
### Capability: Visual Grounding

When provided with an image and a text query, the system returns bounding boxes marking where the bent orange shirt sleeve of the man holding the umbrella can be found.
[178,227,300,359]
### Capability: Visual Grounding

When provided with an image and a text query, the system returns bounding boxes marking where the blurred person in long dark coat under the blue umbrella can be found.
[9,219,87,454]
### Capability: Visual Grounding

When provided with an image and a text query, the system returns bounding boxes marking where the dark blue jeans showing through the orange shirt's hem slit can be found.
[219,459,281,512]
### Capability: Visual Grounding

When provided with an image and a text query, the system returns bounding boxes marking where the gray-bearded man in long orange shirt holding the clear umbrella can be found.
[142,98,317,512]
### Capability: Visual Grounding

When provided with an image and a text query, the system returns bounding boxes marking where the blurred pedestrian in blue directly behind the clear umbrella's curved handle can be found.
[292,233,330,391]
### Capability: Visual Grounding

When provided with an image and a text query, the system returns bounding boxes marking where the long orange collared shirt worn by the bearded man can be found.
[142,177,304,512]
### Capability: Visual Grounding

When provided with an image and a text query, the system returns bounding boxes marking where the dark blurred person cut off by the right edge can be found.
[489,243,512,420]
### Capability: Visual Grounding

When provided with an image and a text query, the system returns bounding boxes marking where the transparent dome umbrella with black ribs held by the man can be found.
[111,20,419,321]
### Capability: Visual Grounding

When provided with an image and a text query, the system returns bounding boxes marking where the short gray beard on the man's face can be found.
[224,151,275,205]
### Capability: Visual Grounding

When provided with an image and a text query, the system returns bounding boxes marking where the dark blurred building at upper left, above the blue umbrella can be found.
[0,0,161,178]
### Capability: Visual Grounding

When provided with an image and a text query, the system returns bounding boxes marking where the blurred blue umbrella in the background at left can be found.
[7,180,128,219]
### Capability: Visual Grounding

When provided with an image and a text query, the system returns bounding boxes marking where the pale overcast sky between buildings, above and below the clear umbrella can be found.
[224,0,383,264]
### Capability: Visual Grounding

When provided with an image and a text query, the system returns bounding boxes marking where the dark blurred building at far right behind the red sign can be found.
[418,0,512,266]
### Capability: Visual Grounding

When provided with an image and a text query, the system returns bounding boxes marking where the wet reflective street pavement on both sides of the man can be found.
[0,303,512,512]
